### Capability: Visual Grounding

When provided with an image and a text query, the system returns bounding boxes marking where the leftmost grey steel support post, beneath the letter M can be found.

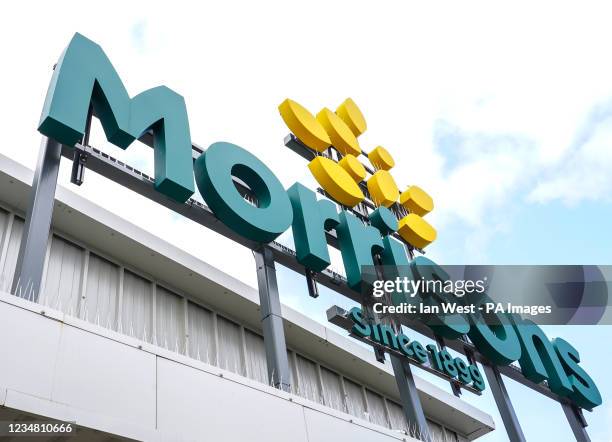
[11,137,62,301]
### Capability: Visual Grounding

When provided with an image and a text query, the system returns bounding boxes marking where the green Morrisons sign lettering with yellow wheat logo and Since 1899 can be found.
[39,34,602,409]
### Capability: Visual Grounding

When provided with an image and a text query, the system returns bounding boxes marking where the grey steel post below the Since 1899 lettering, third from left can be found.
[389,355,431,442]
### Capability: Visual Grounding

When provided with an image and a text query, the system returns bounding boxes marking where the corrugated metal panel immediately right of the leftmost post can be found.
[39,235,82,319]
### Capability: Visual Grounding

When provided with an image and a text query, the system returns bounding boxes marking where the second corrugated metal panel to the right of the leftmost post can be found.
[82,253,119,329]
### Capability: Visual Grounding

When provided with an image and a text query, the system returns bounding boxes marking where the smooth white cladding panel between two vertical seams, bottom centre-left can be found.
[157,358,311,442]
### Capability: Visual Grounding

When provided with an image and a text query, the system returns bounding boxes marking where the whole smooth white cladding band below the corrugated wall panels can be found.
[0,294,426,442]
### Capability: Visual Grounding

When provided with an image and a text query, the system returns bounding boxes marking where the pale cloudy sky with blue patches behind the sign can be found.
[0,0,612,441]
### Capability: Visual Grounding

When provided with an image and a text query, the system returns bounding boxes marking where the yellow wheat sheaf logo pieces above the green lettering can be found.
[278,98,436,249]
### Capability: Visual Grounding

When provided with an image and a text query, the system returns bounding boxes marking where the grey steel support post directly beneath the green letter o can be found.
[253,248,291,391]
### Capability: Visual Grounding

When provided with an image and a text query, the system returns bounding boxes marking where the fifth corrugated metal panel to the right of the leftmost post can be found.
[187,302,216,365]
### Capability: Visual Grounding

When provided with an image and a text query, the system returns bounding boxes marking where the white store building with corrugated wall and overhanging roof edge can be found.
[0,151,494,442]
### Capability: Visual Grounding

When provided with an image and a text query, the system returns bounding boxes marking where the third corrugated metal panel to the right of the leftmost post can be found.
[120,270,153,342]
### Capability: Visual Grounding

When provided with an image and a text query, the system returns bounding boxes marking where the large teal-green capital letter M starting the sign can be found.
[38,33,194,202]
